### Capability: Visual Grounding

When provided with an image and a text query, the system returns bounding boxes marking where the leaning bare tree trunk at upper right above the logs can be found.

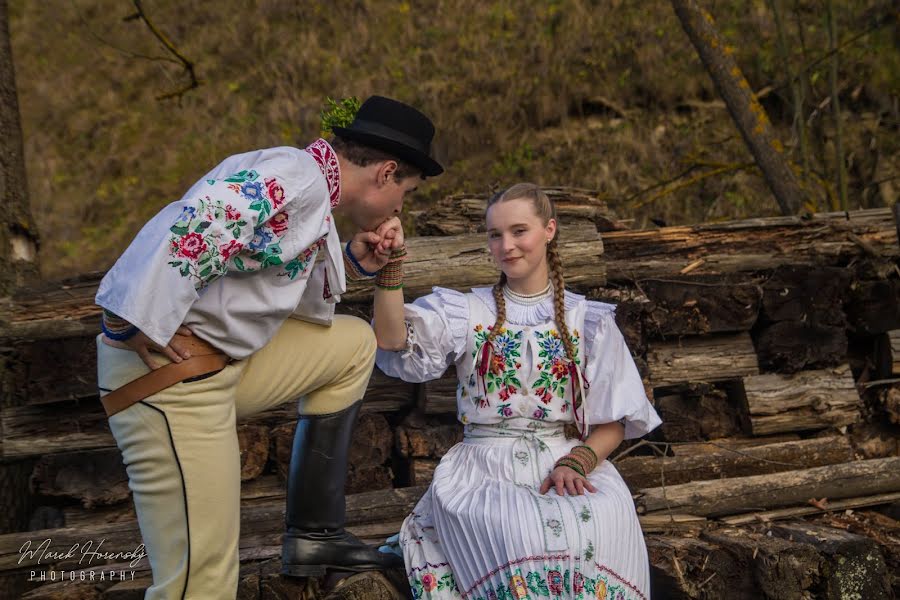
[672,0,804,215]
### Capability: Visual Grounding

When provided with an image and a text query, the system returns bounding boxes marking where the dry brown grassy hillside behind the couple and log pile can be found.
[10,0,900,276]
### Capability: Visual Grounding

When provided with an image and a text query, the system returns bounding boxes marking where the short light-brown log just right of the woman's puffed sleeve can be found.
[647,333,759,387]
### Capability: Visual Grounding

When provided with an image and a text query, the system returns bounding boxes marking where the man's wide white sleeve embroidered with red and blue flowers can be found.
[95,148,328,345]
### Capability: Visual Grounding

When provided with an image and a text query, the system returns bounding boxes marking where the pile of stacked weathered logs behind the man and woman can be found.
[0,188,900,599]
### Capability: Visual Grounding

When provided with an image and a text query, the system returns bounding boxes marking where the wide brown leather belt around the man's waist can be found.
[100,334,231,418]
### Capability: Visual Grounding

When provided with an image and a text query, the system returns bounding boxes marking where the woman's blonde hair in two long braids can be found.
[485,183,576,364]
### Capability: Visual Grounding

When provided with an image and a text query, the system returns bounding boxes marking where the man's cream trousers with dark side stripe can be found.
[97,315,376,600]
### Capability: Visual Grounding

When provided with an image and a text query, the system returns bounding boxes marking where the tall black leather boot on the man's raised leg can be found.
[281,400,403,577]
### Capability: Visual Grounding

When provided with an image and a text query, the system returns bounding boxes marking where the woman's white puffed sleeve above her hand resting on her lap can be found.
[584,302,662,439]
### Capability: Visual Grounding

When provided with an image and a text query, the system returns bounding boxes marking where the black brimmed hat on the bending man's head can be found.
[331,96,444,177]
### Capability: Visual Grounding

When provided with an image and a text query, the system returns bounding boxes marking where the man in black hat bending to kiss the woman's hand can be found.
[96,96,443,600]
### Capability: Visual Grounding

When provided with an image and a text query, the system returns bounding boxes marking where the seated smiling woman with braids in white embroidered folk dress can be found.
[374,183,660,600]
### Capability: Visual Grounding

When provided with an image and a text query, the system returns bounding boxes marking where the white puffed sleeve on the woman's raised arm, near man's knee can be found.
[375,287,469,383]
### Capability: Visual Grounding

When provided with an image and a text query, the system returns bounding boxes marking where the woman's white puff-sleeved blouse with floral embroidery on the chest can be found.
[376,287,662,439]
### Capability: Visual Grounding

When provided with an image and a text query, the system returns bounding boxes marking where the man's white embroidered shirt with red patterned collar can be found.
[95,139,346,359]
